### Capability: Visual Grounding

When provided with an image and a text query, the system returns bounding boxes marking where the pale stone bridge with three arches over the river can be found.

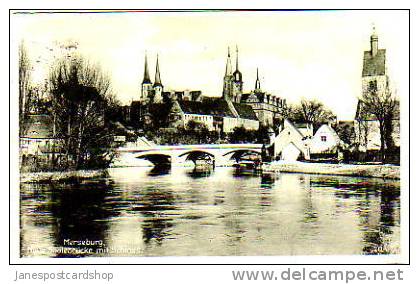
[117,144,262,166]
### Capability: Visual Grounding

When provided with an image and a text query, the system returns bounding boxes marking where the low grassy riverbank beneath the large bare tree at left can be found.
[20,169,107,183]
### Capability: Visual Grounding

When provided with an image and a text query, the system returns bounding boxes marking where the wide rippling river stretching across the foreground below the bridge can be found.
[20,167,400,257]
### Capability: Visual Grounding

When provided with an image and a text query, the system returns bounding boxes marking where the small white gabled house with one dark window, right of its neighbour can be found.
[310,124,340,154]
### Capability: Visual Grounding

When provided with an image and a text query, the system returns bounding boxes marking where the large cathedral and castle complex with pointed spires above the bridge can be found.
[130,47,285,133]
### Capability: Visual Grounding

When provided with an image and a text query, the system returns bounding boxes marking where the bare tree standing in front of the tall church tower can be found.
[360,83,399,161]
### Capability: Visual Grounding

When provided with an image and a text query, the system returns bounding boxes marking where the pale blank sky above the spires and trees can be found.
[11,11,409,120]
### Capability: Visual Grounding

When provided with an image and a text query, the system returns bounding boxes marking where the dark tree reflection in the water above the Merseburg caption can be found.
[22,180,114,257]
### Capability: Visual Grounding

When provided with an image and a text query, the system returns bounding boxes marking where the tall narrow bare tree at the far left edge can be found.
[19,41,31,134]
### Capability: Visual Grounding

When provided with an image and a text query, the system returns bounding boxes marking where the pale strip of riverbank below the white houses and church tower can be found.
[262,161,400,179]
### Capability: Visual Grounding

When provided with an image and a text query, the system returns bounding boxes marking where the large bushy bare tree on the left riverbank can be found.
[50,56,115,168]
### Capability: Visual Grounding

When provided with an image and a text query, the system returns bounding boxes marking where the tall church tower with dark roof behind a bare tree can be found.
[354,27,400,152]
